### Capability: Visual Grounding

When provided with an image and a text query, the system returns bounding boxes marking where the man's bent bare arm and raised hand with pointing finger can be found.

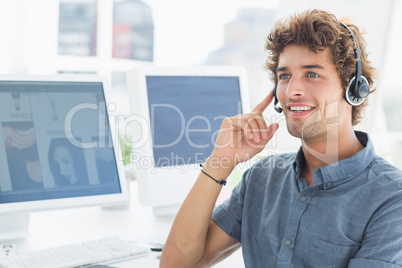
[160,92,278,268]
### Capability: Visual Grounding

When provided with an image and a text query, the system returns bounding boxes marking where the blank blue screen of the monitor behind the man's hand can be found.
[146,75,242,167]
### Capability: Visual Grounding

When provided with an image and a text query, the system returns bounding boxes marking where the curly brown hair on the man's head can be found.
[265,9,376,125]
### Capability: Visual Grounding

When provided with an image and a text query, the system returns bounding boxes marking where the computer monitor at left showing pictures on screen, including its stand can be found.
[0,75,129,240]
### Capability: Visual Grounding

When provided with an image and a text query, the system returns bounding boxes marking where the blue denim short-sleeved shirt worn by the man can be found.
[212,132,402,268]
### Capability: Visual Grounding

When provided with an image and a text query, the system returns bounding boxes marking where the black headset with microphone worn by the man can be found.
[273,22,370,113]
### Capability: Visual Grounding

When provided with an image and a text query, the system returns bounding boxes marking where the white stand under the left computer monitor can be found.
[0,213,30,241]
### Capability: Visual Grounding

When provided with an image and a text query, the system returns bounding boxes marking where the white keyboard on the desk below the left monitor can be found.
[0,237,150,268]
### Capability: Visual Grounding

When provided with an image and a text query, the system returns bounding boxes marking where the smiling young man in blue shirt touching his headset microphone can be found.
[161,10,402,268]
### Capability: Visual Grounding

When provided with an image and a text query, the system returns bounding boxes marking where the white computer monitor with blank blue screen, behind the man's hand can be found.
[126,66,249,216]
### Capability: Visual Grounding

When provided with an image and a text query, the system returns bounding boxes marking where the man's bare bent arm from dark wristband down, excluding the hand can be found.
[160,164,239,267]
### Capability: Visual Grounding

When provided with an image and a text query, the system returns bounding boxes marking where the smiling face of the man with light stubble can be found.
[277,45,352,141]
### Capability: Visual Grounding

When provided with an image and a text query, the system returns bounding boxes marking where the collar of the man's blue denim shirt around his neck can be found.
[293,131,375,189]
